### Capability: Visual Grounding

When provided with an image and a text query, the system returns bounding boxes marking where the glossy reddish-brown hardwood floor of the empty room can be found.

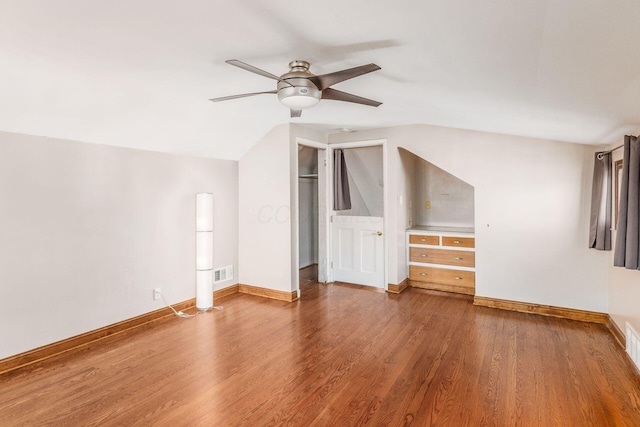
[0,283,640,427]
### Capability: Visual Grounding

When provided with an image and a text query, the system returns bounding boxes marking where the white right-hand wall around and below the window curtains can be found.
[608,130,640,340]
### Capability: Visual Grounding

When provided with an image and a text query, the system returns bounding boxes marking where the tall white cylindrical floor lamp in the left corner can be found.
[196,193,222,311]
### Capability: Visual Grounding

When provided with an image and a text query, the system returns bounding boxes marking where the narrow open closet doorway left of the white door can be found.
[297,141,327,291]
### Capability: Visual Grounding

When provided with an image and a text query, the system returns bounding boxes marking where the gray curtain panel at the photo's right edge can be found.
[613,135,640,270]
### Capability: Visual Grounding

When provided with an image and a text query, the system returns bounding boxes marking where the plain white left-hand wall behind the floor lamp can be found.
[0,132,238,358]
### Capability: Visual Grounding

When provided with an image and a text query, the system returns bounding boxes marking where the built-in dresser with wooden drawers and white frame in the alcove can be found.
[407,226,476,295]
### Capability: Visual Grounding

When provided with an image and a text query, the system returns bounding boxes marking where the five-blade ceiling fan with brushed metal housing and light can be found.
[210,59,382,117]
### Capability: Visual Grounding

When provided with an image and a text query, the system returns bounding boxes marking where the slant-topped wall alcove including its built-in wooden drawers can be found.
[400,149,476,295]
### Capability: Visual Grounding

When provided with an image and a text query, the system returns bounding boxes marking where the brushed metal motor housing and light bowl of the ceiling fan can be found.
[278,60,322,110]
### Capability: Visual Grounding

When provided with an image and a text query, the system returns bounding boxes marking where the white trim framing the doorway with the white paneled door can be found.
[328,139,389,291]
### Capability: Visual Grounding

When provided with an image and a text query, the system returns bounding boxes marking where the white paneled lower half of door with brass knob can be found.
[331,215,384,289]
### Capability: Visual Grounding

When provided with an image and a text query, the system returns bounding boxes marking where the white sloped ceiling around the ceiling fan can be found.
[0,0,640,159]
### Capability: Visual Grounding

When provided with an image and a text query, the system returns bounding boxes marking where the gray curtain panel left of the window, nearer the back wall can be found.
[589,153,612,251]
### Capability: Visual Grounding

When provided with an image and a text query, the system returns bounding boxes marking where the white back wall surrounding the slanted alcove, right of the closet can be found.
[330,125,608,312]
